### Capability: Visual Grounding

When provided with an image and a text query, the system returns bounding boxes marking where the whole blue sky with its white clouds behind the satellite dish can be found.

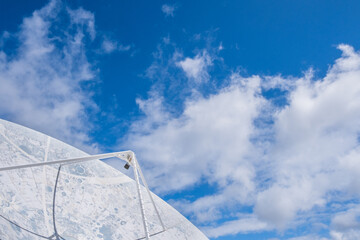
[0,0,360,240]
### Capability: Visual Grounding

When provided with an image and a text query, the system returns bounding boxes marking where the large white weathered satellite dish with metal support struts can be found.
[0,119,207,240]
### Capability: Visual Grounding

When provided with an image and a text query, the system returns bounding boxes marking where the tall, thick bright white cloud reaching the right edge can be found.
[255,45,360,227]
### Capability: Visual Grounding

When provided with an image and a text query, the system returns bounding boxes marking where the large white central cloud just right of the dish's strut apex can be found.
[128,75,262,194]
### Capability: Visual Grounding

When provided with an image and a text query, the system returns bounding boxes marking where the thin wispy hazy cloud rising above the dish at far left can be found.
[0,0,96,150]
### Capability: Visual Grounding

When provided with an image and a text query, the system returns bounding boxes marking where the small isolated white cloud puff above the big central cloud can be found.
[176,50,212,84]
